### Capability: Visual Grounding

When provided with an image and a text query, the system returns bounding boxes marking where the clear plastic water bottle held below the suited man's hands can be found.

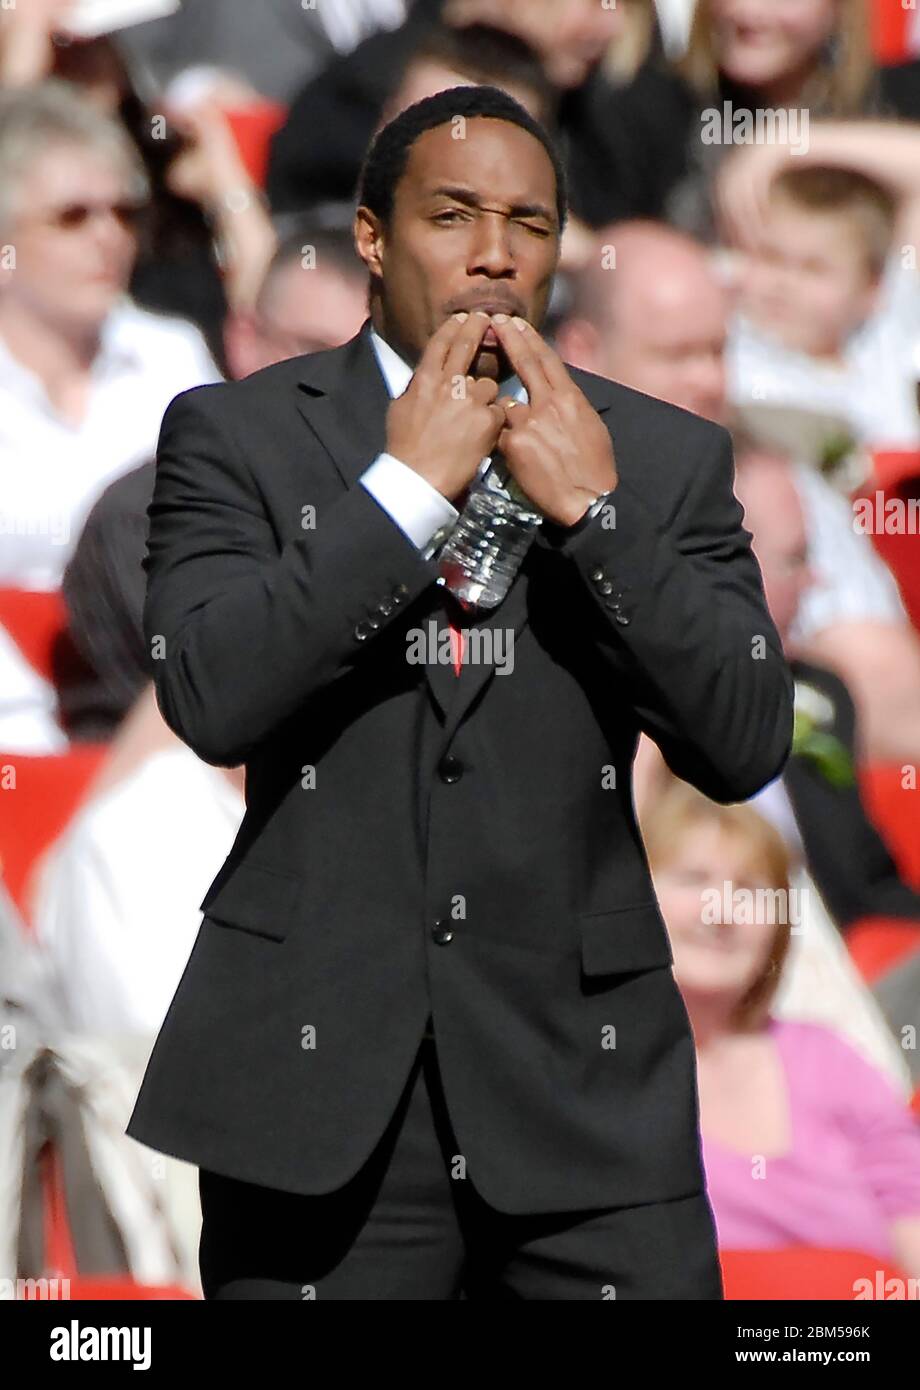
[438,452,543,609]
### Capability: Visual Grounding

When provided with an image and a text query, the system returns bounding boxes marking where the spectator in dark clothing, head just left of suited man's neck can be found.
[60,227,367,741]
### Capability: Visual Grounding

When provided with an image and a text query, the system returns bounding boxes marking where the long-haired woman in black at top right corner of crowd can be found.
[595,0,920,240]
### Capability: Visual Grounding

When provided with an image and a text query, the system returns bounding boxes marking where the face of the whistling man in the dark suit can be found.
[356,117,559,381]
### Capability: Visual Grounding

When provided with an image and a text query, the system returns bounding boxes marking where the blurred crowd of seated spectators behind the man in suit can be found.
[0,0,920,1293]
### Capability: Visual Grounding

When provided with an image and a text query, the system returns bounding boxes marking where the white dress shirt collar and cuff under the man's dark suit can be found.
[359,329,528,550]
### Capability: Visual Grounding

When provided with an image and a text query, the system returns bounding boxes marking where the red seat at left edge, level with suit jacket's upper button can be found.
[0,744,108,922]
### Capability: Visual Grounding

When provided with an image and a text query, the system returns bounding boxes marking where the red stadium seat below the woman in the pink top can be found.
[718,1245,907,1302]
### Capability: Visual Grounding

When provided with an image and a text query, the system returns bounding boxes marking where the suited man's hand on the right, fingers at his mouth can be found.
[492,314,617,527]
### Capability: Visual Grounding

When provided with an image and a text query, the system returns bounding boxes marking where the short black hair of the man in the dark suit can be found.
[359,86,567,234]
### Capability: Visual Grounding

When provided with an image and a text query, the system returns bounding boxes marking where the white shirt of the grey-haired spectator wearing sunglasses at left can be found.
[0,297,221,589]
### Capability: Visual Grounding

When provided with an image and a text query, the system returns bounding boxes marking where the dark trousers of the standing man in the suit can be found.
[199,1037,723,1301]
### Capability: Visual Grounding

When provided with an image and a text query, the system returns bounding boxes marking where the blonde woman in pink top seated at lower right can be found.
[645,784,920,1277]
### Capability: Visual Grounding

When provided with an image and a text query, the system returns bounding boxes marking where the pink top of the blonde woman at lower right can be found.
[702,1019,920,1259]
